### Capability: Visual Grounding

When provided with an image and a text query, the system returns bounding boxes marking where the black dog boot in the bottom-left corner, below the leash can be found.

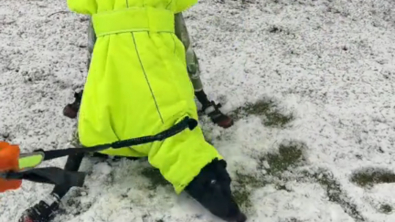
[19,194,60,222]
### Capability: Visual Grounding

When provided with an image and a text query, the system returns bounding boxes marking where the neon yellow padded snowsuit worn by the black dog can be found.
[67,0,222,193]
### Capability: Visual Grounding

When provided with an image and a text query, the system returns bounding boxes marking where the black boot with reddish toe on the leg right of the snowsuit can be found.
[195,90,233,128]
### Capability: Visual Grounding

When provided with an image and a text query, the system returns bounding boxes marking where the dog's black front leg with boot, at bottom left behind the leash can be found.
[19,154,84,222]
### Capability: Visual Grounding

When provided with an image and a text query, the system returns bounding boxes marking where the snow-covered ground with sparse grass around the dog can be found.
[0,0,395,222]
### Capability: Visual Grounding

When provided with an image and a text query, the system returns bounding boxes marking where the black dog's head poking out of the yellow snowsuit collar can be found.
[185,159,247,222]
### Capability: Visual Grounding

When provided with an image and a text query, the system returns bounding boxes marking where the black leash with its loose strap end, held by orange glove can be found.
[0,117,198,187]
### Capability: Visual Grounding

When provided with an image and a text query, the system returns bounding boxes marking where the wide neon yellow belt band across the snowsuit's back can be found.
[92,7,174,37]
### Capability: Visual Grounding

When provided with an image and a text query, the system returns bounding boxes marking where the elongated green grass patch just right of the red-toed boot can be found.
[231,100,294,127]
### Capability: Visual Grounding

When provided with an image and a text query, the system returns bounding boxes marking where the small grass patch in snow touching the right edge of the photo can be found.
[351,168,395,187]
